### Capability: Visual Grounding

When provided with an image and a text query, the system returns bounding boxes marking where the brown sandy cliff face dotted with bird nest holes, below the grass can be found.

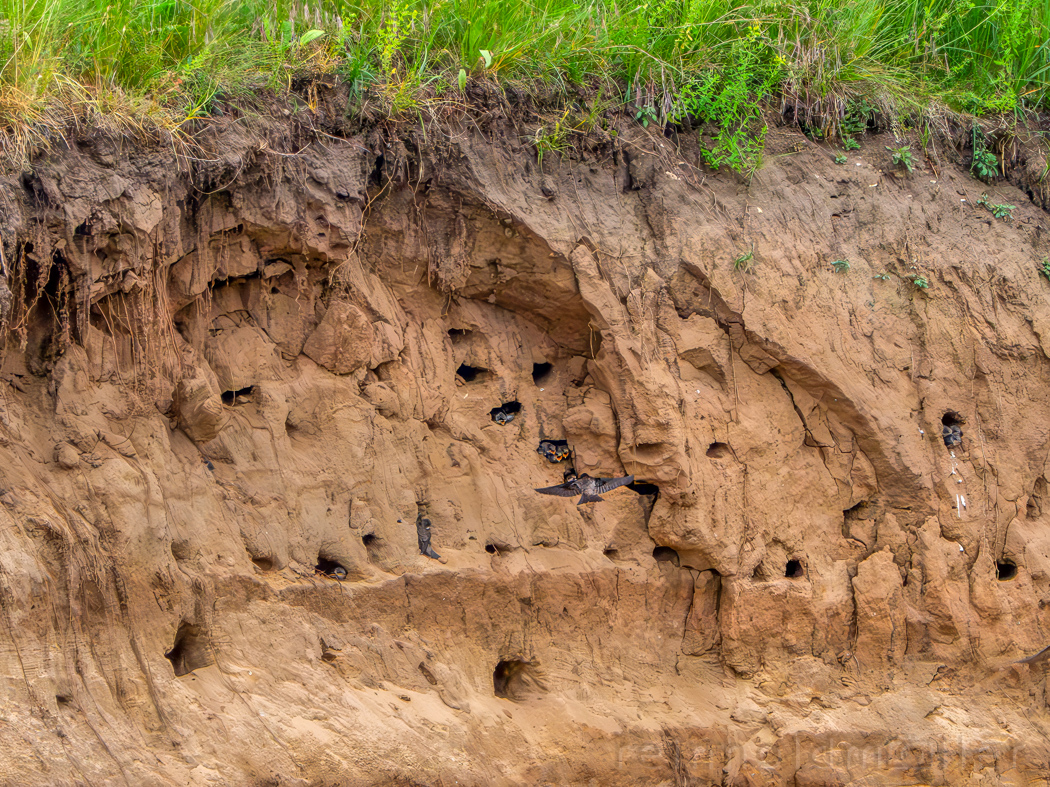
[0,109,1050,787]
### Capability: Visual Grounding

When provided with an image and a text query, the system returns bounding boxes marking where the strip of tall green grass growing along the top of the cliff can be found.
[0,0,1050,155]
